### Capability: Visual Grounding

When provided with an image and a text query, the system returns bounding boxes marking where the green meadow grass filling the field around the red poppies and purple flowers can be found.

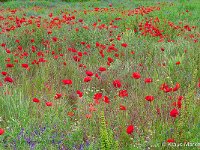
[0,0,200,150]
